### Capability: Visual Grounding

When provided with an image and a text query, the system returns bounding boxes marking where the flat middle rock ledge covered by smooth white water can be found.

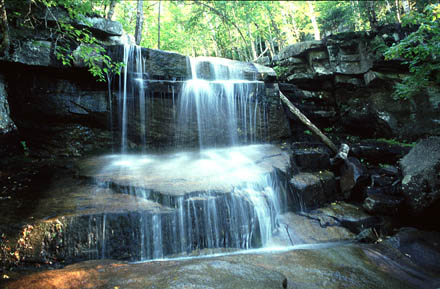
[79,145,290,196]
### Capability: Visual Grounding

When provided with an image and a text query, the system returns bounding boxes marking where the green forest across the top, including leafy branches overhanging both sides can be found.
[0,0,440,97]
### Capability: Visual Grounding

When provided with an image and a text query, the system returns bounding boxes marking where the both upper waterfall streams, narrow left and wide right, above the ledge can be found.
[112,45,268,153]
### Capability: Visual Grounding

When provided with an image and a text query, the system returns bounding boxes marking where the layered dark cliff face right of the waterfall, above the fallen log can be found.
[276,29,440,140]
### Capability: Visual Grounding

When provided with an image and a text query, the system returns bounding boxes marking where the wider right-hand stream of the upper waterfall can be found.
[178,57,264,149]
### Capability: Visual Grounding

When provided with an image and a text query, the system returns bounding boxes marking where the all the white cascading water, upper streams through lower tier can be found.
[89,45,289,260]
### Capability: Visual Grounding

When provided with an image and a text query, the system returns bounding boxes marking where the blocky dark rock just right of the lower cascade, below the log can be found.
[290,171,341,211]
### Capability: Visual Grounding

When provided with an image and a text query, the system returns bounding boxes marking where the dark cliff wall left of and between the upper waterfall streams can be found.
[0,10,289,157]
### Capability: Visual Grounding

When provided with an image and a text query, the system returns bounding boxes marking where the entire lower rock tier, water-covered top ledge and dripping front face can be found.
[3,146,296,263]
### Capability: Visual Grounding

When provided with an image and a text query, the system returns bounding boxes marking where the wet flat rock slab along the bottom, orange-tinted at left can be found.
[5,241,439,289]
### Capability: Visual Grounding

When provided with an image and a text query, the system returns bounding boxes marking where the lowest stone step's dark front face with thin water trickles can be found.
[9,185,264,264]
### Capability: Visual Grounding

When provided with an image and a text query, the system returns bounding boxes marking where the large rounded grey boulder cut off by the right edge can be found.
[400,137,440,214]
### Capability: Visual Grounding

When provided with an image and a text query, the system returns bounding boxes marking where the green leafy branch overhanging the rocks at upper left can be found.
[6,0,122,81]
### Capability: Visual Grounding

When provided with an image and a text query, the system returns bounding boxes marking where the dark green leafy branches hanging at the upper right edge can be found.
[385,4,440,99]
